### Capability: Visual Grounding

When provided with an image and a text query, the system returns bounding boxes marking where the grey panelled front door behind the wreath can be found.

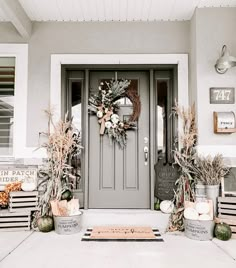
[89,71,150,208]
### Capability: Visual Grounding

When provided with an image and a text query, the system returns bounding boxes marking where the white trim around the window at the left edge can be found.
[0,44,28,158]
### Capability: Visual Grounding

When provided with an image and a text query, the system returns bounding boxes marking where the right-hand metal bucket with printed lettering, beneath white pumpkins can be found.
[184,219,215,241]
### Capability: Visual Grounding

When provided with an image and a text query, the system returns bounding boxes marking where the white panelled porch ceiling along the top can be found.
[0,0,236,22]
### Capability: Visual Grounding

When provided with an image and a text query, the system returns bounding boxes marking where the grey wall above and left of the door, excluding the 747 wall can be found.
[0,22,189,147]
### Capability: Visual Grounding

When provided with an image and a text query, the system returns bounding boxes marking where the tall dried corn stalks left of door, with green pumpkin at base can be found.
[33,111,81,232]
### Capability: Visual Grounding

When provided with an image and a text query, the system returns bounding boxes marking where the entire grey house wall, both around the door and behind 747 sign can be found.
[0,8,236,165]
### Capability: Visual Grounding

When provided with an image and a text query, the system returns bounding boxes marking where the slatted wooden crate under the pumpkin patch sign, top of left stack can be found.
[9,191,39,212]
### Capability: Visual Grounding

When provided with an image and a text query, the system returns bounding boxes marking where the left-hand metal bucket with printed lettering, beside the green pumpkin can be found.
[53,212,82,235]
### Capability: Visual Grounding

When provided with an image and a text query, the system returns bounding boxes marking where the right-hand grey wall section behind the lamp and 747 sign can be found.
[190,8,236,165]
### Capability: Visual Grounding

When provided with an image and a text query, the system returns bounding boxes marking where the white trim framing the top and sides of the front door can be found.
[50,54,189,125]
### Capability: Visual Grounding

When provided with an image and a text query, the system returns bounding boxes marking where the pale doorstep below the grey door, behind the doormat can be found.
[81,209,170,233]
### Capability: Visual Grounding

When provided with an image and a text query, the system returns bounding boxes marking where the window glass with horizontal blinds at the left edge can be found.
[0,58,15,155]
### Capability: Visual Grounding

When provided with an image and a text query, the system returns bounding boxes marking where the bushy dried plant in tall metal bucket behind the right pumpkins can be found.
[192,154,229,214]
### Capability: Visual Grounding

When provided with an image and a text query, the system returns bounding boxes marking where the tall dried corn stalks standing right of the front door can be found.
[168,103,198,231]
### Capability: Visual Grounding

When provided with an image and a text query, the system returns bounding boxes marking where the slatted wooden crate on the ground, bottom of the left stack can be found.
[0,209,31,231]
